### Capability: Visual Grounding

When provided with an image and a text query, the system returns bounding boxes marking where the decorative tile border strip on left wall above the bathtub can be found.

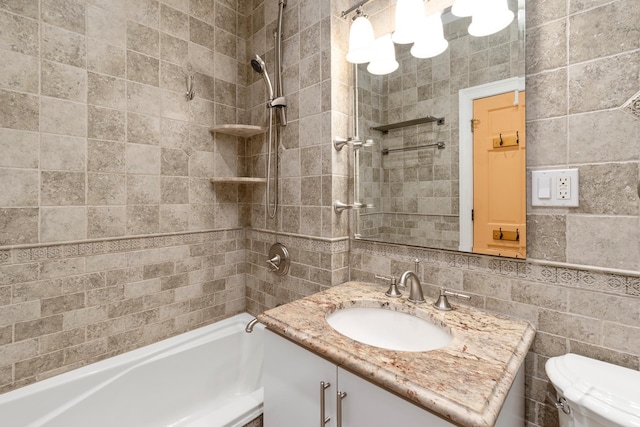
[0,228,245,265]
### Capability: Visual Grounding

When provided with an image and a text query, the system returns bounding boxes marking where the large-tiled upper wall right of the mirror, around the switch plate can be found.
[526,0,640,271]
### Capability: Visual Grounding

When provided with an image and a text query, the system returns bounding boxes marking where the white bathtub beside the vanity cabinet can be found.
[0,314,264,427]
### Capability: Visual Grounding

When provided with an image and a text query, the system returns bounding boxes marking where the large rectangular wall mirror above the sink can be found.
[354,0,526,258]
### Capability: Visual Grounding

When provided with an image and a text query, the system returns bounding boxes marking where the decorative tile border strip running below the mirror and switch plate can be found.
[351,240,640,297]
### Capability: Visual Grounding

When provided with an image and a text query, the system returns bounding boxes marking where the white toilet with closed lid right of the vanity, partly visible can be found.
[545,354,640,427]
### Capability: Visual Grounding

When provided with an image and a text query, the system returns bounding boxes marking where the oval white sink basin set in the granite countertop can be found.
[327,307,452,351]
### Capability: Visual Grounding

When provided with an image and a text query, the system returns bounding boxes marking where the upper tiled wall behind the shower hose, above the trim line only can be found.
[247,0,351,238]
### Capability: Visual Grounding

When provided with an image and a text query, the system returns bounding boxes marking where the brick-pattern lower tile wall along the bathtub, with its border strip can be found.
[0,230,245,392]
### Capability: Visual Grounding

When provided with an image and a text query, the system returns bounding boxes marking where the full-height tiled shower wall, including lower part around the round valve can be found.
[246,0,352,314]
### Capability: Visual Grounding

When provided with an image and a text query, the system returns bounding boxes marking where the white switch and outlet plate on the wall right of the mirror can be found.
[531,169,579,207]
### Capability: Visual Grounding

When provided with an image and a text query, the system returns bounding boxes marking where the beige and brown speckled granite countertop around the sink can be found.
[258,282,535,427]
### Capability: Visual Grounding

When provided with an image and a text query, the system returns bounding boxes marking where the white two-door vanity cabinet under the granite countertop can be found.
[264,330,453,427]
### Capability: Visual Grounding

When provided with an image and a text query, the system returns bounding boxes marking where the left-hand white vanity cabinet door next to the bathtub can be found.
[263,330,337,427]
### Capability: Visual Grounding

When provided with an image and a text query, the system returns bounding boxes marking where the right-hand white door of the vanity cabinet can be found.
[338,368,454,427]
